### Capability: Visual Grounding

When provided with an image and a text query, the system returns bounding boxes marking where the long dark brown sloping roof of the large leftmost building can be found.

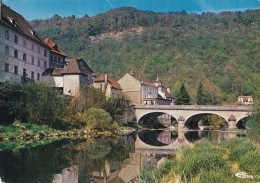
[0,2,47,47]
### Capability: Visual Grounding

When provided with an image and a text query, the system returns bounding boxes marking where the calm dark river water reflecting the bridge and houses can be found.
[0,131,244,183]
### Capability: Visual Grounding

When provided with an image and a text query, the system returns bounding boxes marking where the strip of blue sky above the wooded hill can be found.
[2,0,260,20]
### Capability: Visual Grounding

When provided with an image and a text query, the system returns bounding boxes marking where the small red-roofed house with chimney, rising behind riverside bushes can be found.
[93,74,122,99]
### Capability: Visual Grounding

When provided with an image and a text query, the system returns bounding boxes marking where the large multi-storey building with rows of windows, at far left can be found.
[0,2,49,82]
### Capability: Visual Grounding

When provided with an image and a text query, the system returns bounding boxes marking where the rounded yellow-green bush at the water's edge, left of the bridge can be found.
[84,107,116,131]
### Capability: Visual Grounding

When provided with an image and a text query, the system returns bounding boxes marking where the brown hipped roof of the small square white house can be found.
[62,58,93,75]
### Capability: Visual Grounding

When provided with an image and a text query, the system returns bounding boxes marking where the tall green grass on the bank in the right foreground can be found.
[138,138,260,183]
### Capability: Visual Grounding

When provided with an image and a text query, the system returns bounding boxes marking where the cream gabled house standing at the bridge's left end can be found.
[118,70,158,105]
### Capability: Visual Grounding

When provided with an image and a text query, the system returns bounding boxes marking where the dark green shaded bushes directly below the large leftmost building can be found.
[0,82,67,124]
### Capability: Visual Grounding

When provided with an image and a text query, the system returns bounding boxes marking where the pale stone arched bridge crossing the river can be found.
[134,105,252,129]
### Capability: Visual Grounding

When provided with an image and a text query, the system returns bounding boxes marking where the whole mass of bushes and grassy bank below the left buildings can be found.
[0,82,127,150]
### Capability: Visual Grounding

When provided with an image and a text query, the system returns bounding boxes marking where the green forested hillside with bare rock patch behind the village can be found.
[31,8,260,103]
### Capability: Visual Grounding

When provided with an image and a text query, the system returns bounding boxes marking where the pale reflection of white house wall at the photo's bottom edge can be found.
[52,165,79,183]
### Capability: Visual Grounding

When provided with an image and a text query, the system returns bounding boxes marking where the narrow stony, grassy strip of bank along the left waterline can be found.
[0,122,135,151]
